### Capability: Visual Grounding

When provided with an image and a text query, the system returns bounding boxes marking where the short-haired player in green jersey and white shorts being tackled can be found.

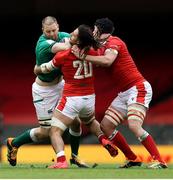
[7,16,88,167]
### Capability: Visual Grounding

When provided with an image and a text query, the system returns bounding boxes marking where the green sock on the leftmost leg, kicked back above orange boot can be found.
[12,130,33,147]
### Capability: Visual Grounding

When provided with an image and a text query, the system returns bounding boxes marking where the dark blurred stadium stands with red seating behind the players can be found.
[0,0,173,163]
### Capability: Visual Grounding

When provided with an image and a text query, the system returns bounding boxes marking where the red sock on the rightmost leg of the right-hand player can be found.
[141,135,164,163]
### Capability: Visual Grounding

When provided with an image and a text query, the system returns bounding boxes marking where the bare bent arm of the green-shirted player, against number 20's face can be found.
[51,38,71,54]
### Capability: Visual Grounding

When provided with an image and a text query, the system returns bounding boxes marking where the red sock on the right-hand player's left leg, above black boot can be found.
[111,131,137,160]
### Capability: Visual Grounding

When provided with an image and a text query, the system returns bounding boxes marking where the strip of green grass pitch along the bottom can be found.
[0,164,173,179]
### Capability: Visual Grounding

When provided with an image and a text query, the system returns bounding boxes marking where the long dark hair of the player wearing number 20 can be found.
[78,24,99,49]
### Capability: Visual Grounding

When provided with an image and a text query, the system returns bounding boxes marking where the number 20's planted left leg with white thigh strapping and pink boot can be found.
[50,96,86,168]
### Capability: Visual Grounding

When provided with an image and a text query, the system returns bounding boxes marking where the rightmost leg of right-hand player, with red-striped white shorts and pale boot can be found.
[127,82,167,168]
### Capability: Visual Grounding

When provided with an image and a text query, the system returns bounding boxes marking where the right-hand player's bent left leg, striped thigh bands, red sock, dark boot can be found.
[101,100,141,168]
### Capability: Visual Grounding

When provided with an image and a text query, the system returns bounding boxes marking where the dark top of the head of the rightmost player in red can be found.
[94,18,115,34]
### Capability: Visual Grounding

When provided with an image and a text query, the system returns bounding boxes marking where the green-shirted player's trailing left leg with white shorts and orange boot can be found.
[7,82,60,166]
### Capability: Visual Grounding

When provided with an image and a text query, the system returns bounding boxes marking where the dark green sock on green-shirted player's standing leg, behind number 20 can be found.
[70,134,80,156]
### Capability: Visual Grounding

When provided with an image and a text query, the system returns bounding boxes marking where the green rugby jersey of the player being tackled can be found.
[35,32,70,82]
